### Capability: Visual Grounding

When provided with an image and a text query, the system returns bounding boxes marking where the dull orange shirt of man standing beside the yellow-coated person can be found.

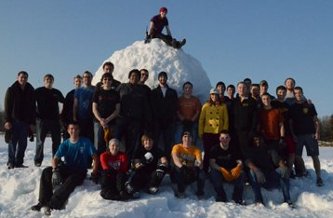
[178,96,201,120]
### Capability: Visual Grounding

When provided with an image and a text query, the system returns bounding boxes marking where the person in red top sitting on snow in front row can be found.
[100,138,129,200]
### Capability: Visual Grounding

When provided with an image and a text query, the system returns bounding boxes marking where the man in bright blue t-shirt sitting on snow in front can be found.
[31,122,98,215]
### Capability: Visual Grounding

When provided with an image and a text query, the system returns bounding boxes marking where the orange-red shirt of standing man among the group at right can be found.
[260,108,283,140]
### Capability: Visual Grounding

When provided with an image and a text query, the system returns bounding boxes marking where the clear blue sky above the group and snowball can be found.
[0,0,333,116]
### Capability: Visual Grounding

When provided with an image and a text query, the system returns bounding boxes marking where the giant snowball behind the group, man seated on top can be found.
[92,39,211,102]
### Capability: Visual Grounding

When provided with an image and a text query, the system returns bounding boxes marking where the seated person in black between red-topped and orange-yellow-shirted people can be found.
[126,134,168,197]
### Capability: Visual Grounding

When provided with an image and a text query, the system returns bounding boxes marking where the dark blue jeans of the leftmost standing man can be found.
[7,121,29,166]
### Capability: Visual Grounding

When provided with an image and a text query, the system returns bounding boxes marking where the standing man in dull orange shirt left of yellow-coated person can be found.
[176,81,201,144]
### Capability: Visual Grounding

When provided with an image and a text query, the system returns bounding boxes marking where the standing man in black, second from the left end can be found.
[34,74,65,167]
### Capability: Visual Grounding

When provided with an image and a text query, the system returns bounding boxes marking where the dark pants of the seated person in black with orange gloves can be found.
[210,169,244,203]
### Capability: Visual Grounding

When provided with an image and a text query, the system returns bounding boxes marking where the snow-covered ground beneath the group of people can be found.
[0,136,333,218]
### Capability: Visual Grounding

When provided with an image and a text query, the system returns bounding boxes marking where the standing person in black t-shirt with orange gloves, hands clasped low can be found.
[92,73,120,155]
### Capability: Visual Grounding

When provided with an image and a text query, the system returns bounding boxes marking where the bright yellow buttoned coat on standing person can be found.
[199,103,229,137]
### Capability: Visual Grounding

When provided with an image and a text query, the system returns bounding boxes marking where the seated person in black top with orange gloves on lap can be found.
[209,131,244,204]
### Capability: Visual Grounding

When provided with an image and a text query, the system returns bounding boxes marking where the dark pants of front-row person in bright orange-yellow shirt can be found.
[171,166,205,193]
